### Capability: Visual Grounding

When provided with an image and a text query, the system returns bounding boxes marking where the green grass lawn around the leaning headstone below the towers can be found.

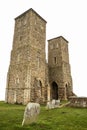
[0,102,87,130]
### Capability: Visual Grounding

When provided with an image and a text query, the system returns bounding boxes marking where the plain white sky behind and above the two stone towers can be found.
[0,0,87,100]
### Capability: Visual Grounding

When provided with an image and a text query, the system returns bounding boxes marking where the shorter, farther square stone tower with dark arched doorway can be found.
[48,36,72,100]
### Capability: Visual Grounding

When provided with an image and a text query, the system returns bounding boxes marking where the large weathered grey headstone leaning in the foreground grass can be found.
[22,103,40,126]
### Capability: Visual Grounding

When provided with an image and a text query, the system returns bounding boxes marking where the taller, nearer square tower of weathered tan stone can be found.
[6,9,46,104]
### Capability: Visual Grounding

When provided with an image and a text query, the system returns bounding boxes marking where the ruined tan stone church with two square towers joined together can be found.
[5,9,73,104]
